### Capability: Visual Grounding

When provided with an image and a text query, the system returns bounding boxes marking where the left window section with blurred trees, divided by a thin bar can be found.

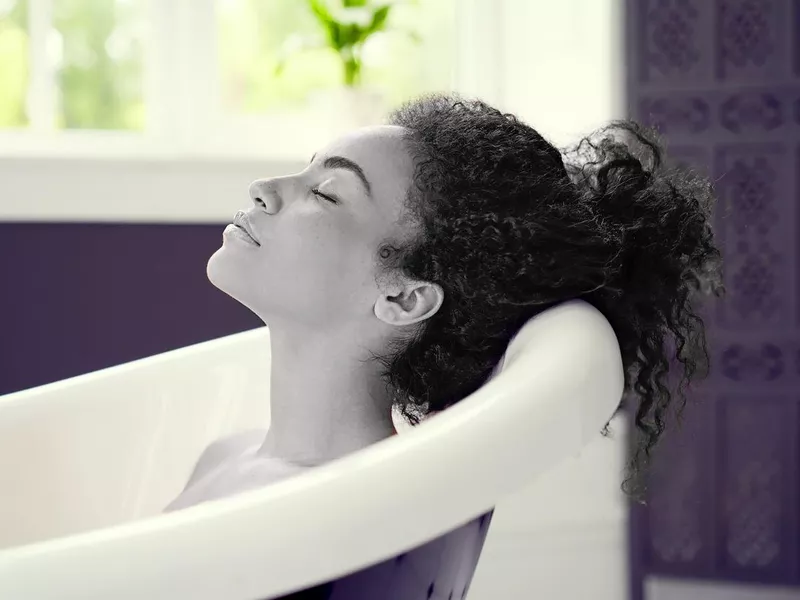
[0,0,144,130]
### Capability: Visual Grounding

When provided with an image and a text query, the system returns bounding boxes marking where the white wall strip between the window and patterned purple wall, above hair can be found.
[501,0,625,146]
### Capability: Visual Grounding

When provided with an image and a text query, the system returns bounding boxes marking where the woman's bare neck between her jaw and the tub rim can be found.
[258,326,395,465]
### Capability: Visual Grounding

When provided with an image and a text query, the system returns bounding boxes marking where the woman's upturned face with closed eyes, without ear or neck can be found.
[208,126,413,328]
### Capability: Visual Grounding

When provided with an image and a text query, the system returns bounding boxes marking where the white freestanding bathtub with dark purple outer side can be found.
[0,301,622,600]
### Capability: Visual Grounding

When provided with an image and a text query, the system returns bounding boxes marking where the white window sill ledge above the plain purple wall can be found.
[0,148,308,224]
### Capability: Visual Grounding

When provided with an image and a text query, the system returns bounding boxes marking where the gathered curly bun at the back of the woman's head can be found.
[565,121,714,301]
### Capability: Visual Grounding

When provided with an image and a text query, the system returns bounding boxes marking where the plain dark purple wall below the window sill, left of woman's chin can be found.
[0,223,261,394]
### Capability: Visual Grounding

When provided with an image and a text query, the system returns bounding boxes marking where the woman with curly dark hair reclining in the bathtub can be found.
[168,95,723,510]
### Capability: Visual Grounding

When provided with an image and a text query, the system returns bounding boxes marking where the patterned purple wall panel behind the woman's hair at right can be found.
[627,0,800,599]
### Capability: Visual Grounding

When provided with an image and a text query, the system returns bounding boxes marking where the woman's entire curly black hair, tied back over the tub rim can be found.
[376,94,724,496]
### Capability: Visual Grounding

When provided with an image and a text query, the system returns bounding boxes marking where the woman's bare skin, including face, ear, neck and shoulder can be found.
[168,126,443,510]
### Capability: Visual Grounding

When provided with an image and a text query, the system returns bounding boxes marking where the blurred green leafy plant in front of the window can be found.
[276,0,418,87]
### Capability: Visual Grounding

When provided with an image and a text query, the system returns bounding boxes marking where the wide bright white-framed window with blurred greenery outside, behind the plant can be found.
[0,0,462,158]
